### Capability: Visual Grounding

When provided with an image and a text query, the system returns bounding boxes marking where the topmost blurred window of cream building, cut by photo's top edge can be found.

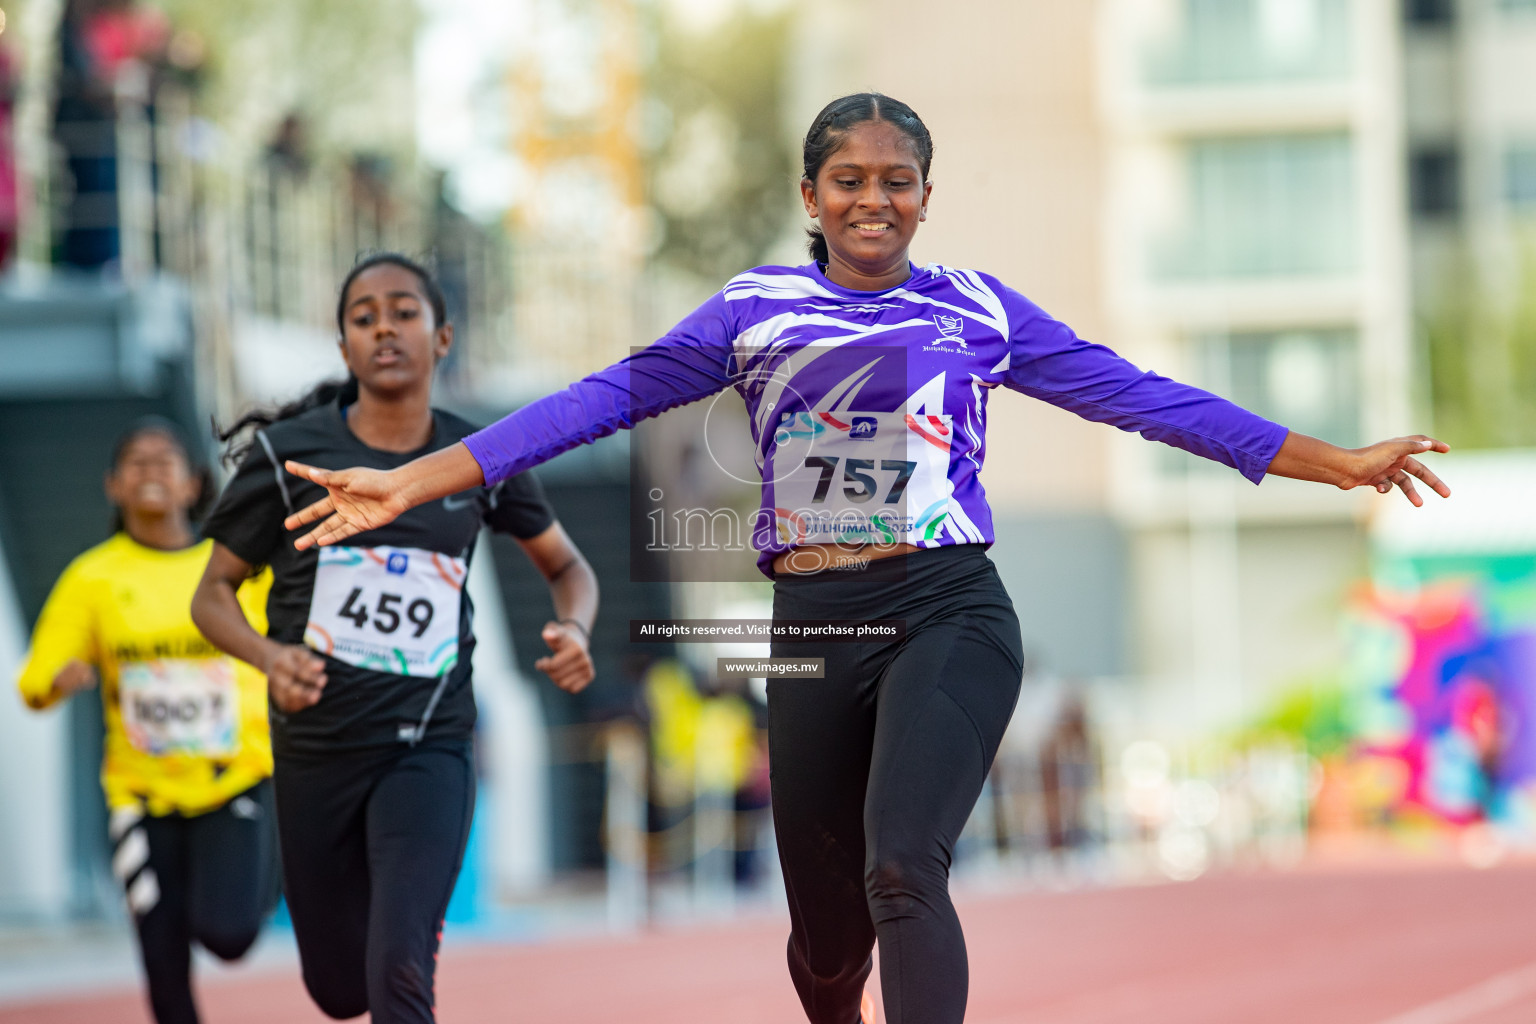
[1143,0,1352,86]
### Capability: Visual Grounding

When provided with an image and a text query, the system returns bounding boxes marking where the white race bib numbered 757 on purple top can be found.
[773,413,952,545]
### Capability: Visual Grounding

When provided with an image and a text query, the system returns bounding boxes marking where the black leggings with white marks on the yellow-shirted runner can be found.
[112,781,276,1024]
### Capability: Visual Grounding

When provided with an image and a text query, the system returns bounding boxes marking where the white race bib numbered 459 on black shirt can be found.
[304,547,468,677]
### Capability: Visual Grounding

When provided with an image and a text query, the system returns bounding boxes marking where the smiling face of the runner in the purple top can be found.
[800,121,934,290]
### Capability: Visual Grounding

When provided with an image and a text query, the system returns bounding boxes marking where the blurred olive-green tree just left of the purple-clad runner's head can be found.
[642,5,799,280]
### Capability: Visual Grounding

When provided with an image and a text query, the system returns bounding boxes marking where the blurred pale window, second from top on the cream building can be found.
[1150,132,1356,281]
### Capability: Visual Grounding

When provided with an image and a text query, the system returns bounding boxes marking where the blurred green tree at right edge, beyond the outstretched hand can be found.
[1418,237,1536,448]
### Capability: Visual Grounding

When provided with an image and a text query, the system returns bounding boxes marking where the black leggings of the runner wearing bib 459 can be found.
[273,740,475,1024]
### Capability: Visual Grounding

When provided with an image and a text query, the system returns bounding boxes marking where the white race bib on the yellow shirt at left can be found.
[117,657,240,757]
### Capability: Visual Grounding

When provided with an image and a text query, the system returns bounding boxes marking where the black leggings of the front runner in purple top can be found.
[768,545,1023,1024]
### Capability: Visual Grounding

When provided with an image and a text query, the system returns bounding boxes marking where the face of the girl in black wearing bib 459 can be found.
[341,263,453,396]
